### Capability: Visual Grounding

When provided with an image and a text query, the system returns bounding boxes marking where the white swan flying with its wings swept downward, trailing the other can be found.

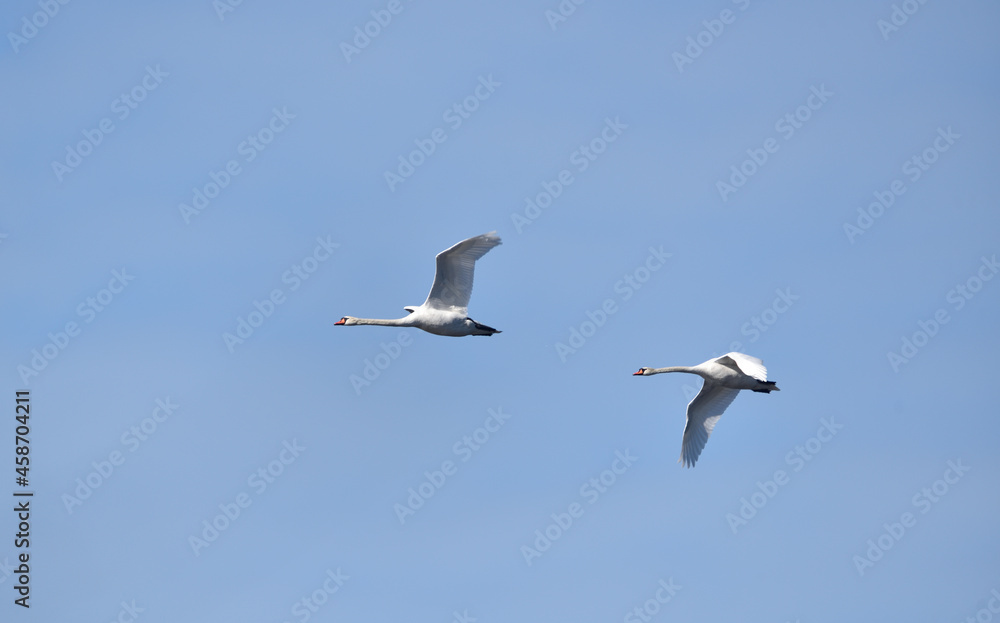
[632,353,780,467]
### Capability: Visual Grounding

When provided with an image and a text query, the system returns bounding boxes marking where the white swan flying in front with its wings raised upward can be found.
[333,231,500,337]
